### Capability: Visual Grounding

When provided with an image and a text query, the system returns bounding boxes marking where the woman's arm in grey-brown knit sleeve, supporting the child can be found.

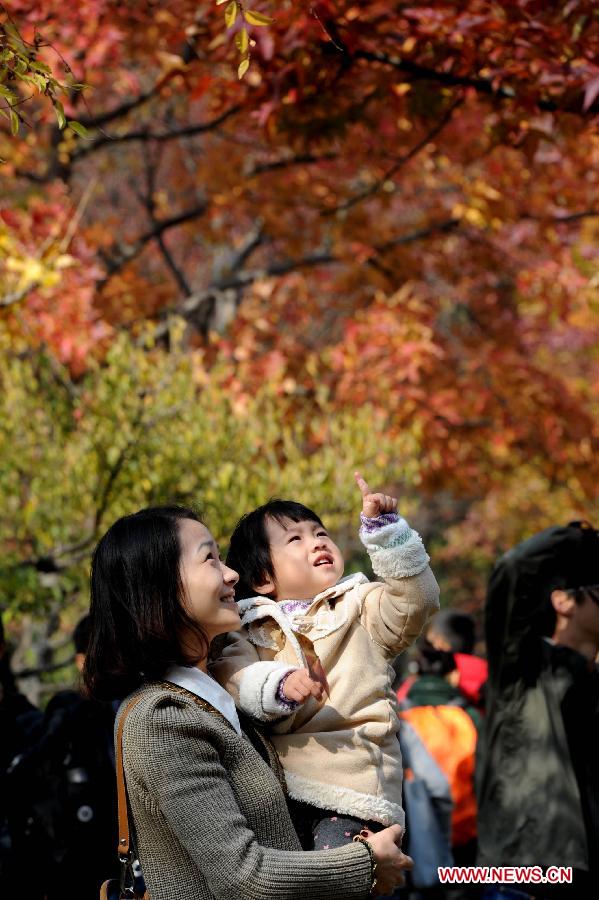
[125,705,371,900]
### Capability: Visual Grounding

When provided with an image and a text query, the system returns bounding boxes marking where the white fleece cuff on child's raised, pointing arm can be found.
[360,513,429,578]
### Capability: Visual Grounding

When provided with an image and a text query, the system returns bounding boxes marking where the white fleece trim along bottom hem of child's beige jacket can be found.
[285,769,405,827]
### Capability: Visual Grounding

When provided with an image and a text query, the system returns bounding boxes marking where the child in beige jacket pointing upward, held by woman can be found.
[211,472,439,850]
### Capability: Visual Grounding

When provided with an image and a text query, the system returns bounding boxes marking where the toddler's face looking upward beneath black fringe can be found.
[258,518,343,600]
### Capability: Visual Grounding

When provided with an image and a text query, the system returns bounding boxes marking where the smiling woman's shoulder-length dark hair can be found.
[83,506,209,700]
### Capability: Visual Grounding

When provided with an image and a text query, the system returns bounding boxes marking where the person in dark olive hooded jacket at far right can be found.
[477,522,599,898]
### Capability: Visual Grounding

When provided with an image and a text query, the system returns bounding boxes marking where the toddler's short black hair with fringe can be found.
[226,500,324,600]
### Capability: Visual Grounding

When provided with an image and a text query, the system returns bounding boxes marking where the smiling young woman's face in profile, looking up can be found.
[179,519,241,640]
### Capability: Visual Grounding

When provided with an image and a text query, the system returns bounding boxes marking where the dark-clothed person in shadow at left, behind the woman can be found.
[8,616,118,900]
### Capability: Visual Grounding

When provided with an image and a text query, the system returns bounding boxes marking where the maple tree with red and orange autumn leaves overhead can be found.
[0,0,599,684]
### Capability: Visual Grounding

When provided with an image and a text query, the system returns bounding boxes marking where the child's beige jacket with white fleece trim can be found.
[210,519,439,825]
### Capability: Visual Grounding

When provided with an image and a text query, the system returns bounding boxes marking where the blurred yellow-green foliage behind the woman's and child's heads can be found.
[0,322,417,614]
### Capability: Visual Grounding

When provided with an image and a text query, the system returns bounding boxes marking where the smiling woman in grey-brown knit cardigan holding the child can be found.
[85,507,411,900]
